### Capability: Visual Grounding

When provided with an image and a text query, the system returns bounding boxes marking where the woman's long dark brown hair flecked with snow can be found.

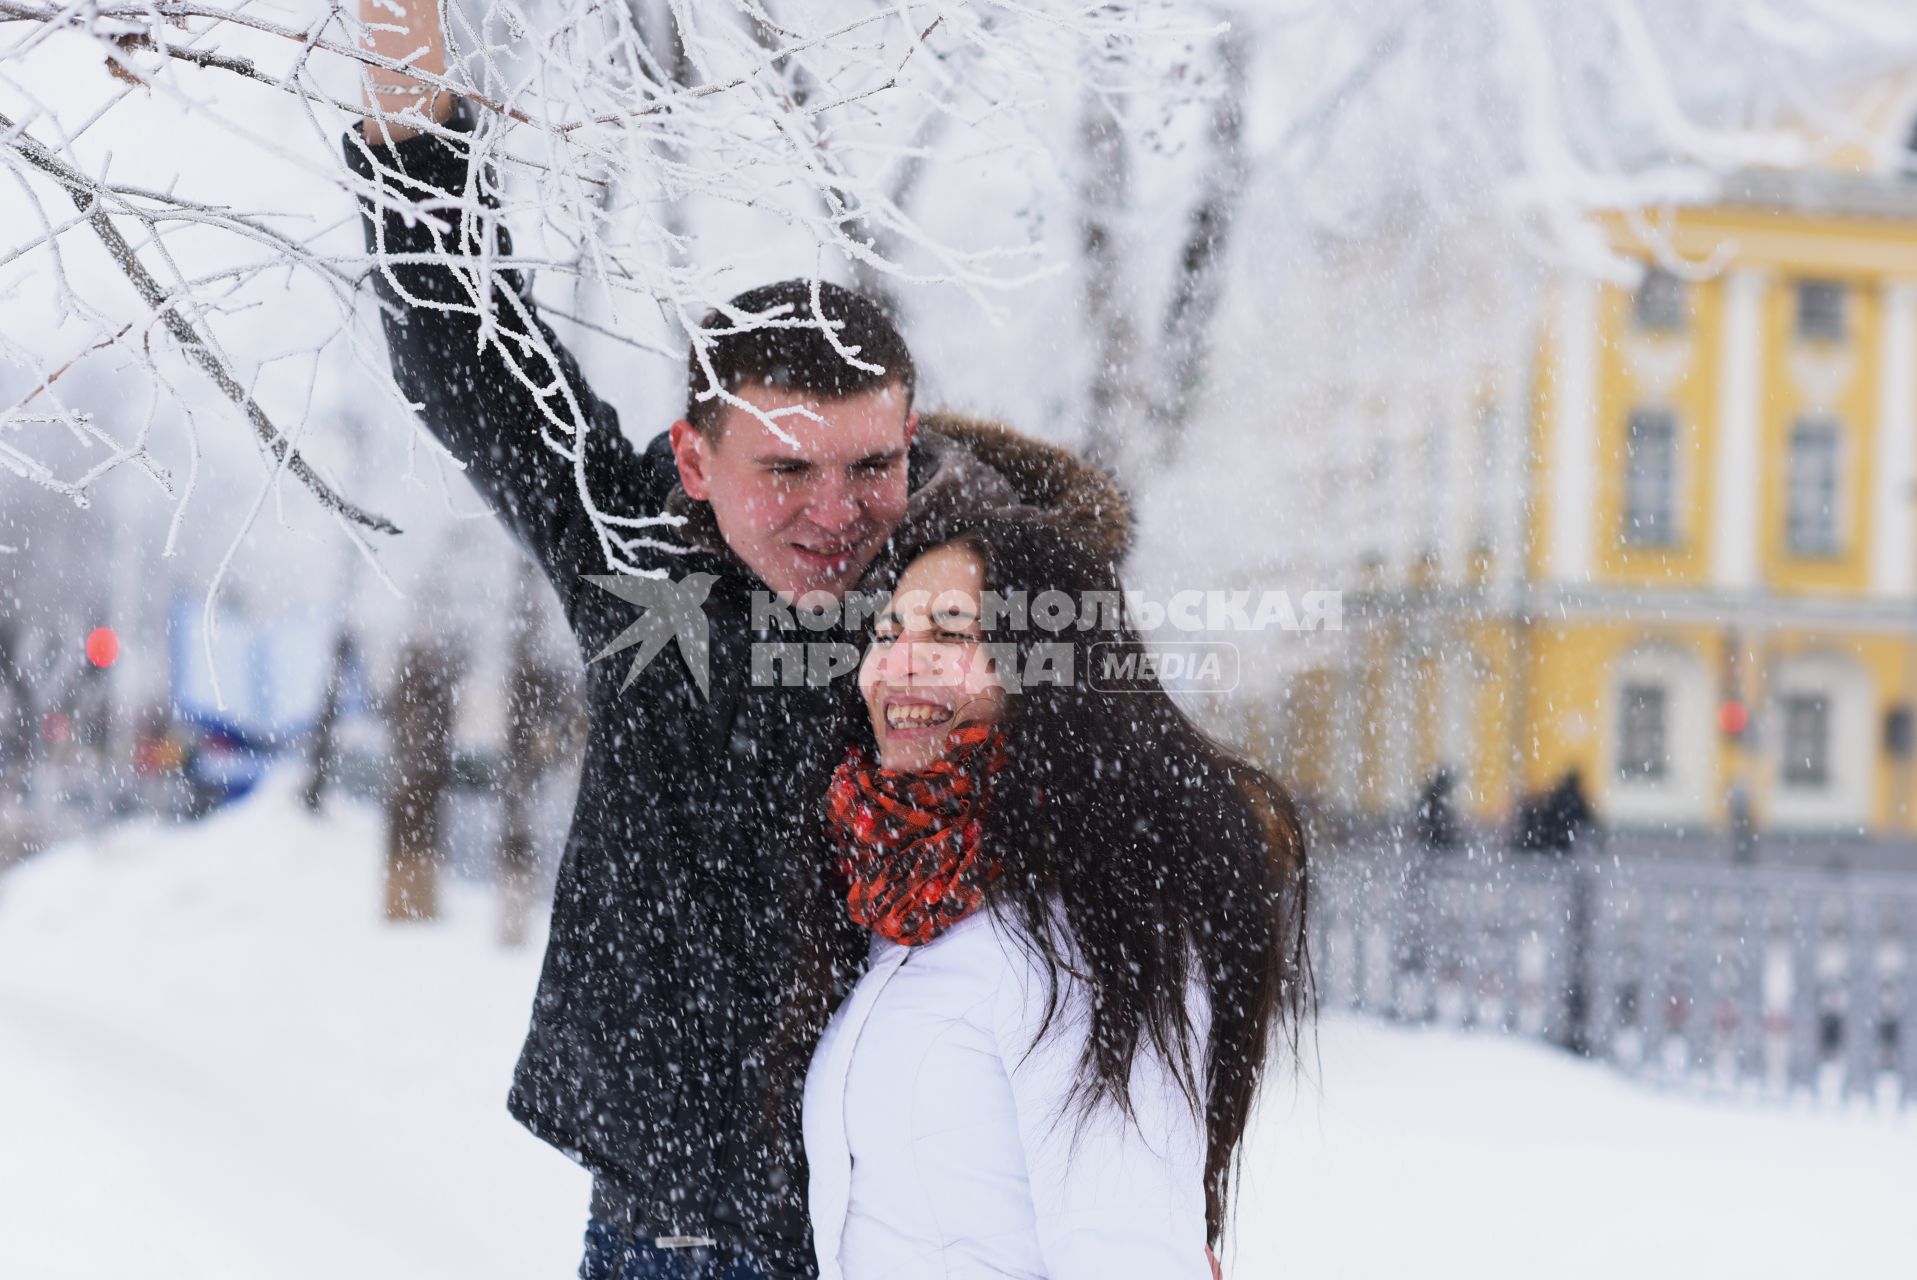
[767,517,1311,1244]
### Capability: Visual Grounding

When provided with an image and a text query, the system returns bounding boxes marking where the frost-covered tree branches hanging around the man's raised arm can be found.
[0,0,1194,565]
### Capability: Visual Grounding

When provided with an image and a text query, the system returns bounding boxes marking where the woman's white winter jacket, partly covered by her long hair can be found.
[803,910,1212,1280]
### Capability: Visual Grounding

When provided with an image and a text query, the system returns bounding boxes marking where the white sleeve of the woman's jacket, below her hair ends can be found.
[999,938,1212,1280]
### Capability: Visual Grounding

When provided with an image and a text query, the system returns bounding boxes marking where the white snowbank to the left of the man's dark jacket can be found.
[0,776,589,1280]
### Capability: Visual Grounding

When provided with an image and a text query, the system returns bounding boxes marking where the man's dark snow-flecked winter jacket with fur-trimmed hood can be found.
[341,100,1129,1276]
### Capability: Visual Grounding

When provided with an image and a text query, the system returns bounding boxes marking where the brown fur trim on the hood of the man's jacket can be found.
[665,410,1131,573]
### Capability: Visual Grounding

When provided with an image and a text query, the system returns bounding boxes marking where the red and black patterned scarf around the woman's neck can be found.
[826,724,1005,947]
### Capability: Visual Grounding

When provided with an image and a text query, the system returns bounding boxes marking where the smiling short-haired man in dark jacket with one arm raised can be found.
[345,0,1129,1280]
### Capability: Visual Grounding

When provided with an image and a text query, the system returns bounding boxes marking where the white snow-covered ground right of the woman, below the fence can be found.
[1227,1017,1917,1280]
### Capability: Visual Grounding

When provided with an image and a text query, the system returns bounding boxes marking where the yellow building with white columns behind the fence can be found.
[1271,160,1917,860]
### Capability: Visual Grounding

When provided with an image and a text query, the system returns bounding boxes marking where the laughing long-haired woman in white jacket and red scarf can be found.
[770,519,1307,1280]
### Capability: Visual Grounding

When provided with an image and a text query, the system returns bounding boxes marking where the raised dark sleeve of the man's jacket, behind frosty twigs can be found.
[343,100,677,602]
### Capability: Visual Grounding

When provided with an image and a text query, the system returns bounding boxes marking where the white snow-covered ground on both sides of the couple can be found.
[0,780,1917,1280]
